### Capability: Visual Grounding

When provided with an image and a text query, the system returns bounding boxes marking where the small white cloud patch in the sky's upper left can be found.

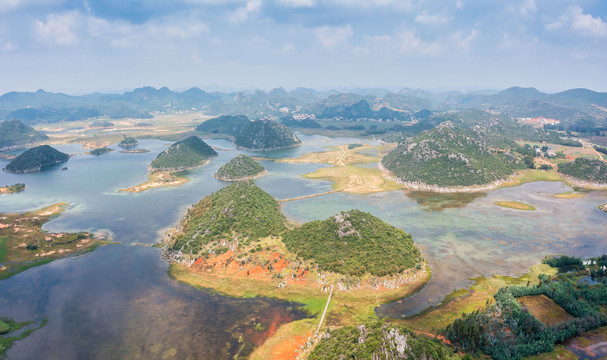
[36,11,82,45]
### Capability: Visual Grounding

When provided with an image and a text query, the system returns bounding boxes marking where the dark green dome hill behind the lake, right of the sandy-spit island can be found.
[235,120,301,150]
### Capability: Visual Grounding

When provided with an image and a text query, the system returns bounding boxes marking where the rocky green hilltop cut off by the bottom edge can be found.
[308,321,460,360]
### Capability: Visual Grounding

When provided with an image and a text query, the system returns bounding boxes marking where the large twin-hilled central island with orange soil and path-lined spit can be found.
[163,181,430,359]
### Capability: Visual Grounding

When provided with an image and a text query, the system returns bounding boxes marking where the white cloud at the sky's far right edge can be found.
[546,5,607,38]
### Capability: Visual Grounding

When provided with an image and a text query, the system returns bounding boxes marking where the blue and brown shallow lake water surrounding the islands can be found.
[0,136,607,359]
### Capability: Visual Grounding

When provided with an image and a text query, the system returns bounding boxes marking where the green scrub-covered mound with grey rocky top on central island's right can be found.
[283,210,422,276]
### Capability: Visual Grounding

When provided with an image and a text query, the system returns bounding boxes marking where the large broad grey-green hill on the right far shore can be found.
[381,122,522,186]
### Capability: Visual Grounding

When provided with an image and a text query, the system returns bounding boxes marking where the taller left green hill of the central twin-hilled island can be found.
[168,181,286,255]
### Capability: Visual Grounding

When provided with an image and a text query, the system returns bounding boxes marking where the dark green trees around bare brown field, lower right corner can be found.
[445,274,607,360]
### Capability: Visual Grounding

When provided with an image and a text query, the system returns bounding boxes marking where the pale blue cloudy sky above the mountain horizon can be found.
[0,0,607,94]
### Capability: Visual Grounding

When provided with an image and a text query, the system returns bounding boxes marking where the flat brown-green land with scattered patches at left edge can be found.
[0,203,106,280]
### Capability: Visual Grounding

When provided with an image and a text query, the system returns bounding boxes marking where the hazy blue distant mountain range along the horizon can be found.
[0,86,607,126]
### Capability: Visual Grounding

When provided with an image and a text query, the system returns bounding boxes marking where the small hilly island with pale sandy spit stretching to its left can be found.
[119,136,217,192]
